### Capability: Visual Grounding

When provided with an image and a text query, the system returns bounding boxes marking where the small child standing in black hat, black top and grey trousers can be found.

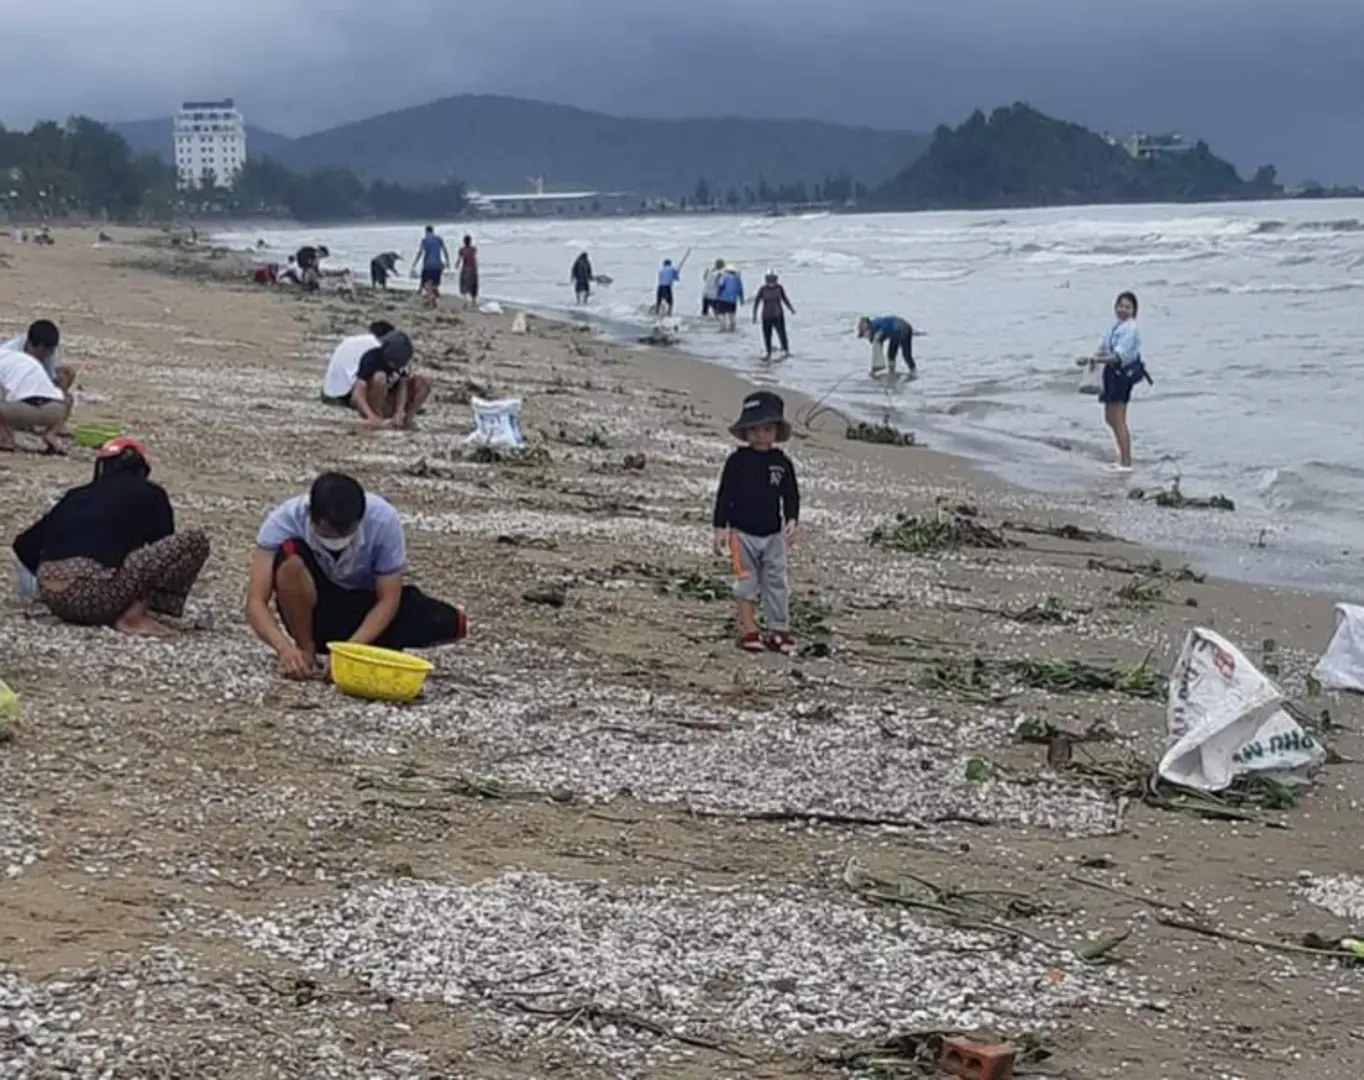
[713,390,801,656]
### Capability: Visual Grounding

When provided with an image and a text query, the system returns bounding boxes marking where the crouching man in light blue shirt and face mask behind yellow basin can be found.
[247,472,469,679]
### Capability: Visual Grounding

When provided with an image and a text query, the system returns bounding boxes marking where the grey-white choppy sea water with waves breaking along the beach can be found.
[216,200,1364,593]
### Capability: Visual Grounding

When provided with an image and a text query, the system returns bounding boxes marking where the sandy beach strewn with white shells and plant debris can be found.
[0,230,1364,1080]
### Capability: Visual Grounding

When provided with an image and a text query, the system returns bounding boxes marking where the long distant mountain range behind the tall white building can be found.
[103,94,926,198]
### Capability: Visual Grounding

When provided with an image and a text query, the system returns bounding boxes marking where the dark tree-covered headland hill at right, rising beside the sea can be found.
[865,104,1282,210]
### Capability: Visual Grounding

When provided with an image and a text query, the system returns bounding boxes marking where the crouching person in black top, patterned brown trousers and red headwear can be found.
[14,439,209,637]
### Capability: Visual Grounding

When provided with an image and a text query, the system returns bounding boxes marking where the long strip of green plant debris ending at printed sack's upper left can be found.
[918,656,1166,700]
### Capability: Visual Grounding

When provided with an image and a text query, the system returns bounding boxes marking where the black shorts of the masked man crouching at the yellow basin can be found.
[274,540,466,652]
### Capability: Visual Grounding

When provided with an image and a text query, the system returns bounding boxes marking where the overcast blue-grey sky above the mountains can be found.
[0,0,1364,181]
